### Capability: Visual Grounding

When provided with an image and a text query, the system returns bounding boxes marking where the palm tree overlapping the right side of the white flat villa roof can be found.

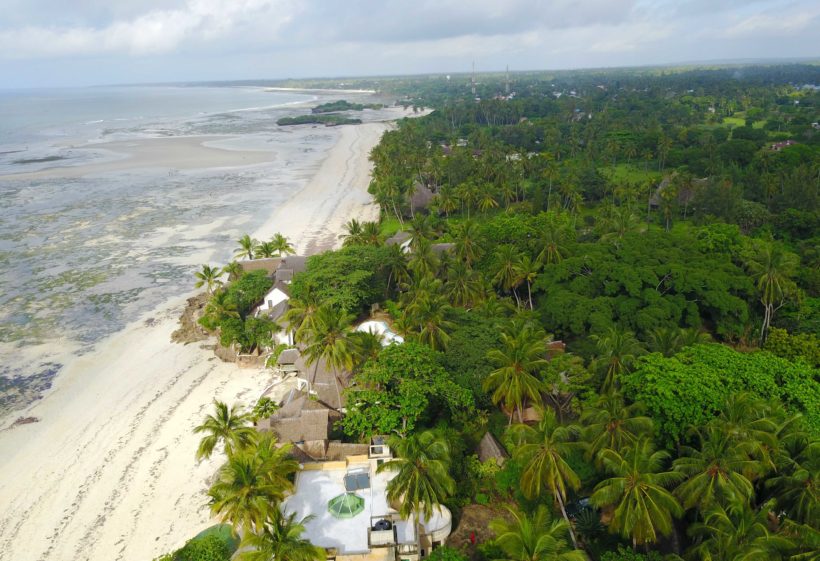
[377,430,456,536]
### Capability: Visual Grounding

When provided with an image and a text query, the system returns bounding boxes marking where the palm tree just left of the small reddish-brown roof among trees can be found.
[483,327,547,424]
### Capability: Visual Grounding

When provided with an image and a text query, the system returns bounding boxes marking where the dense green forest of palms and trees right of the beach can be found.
[191,65,820,561]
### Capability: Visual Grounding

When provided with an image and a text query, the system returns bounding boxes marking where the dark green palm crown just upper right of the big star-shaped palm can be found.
[673,422,759,512]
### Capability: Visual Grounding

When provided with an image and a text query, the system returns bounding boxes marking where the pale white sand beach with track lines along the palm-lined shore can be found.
[0,110,408,561]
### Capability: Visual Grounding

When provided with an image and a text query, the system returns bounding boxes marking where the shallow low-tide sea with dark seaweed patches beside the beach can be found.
[0,86,336,416]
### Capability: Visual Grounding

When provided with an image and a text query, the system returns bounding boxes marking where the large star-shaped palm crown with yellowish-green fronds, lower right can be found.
[589,438,683,545]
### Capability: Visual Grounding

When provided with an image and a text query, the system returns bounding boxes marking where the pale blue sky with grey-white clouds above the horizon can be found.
[0,0,820,88]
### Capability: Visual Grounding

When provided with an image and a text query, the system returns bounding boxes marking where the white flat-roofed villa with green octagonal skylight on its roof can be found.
[282,437,452,561]
